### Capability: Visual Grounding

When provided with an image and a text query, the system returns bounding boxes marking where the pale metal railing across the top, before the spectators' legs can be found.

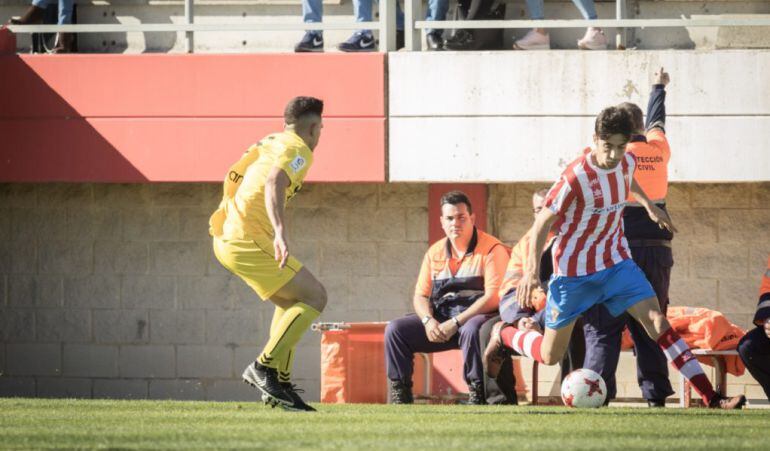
[8,0,770,53]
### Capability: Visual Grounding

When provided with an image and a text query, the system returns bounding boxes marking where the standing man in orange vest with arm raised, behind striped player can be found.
[583,67,674,407]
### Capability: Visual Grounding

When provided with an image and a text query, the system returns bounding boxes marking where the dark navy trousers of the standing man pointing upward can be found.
[583,246,674,400]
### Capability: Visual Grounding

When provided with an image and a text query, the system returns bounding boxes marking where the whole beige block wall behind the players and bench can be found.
[0,183,770,400]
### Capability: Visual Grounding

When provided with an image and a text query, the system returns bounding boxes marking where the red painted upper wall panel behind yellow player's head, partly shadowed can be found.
[0,53,386,182]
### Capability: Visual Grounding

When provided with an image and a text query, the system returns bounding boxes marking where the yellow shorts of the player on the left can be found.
[214,237,302,301]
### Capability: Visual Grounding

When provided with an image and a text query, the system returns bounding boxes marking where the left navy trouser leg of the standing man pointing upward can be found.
[583,305,625,401]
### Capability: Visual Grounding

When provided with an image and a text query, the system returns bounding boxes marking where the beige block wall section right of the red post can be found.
[489,182,770,399]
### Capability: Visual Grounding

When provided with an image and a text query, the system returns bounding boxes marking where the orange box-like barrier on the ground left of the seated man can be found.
[319,322,425,404]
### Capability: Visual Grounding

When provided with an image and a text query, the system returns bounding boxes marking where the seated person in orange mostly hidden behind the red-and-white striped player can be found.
[484,189,585,385]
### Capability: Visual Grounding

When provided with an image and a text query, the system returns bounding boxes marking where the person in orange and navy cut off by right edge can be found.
[738,256,770,401]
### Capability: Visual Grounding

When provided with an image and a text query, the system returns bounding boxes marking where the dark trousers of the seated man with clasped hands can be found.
[385,314,493,383]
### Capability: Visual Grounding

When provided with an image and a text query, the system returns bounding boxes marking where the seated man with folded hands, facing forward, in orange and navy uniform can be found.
[385,191,508,404]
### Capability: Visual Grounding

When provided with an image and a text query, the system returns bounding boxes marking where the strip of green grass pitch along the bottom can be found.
[0,398,770,451]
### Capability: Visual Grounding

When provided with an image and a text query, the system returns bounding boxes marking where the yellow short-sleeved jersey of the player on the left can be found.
[209,131,313,240]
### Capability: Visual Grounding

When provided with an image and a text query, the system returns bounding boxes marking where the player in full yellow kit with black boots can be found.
[209,97,326,411]
